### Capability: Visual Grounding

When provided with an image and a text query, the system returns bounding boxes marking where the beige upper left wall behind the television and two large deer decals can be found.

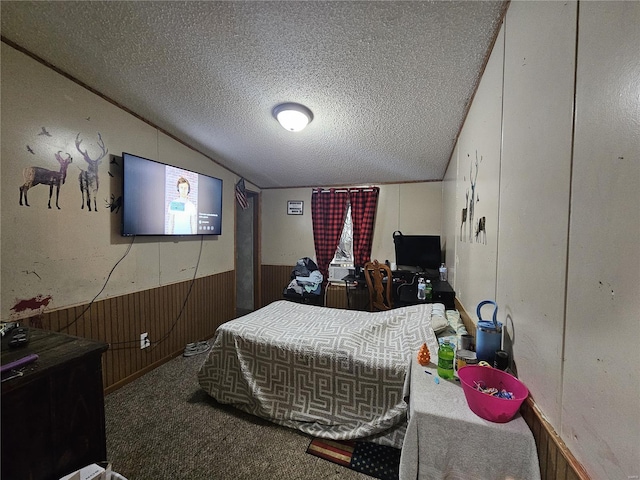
[1,43,236,320]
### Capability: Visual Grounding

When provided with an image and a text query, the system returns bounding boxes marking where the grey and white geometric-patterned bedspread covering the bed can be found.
[198,301,437,447]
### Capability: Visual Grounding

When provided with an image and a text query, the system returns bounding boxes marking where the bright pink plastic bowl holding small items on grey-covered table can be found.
[458,365,529,423]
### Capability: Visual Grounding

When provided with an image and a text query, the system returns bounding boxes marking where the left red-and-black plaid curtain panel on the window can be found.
[311,188,349,282]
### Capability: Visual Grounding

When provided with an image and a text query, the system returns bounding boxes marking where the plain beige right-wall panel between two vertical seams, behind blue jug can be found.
[498,2,577,425]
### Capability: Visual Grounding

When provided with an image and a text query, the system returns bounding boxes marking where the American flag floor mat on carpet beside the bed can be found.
[307,438,400,480]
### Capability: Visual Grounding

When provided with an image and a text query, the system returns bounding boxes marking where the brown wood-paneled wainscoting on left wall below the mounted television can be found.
[28,270,236,393]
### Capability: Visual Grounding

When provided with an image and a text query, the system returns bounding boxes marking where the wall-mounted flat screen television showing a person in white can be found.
[122,152,222,236]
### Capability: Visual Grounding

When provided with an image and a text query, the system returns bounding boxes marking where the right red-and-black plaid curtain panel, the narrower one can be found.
[349,187,380,265]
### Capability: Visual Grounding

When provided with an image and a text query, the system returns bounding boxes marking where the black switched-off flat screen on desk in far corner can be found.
[393,232,442,276]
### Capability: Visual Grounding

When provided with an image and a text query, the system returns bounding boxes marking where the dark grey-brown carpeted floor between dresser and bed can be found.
[105,342,371,480]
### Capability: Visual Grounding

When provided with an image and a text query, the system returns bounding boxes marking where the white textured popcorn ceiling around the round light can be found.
[0,0,507,188]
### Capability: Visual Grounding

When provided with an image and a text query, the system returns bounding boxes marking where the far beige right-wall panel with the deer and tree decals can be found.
[445,23,504,308]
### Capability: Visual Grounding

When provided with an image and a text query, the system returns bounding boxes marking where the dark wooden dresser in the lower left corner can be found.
[1,328,108,480]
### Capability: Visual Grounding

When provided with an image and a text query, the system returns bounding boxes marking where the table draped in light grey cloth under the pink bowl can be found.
[400,356,540,480]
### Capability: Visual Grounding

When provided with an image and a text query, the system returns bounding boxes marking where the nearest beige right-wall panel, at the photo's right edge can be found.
[561,1,640,479]
